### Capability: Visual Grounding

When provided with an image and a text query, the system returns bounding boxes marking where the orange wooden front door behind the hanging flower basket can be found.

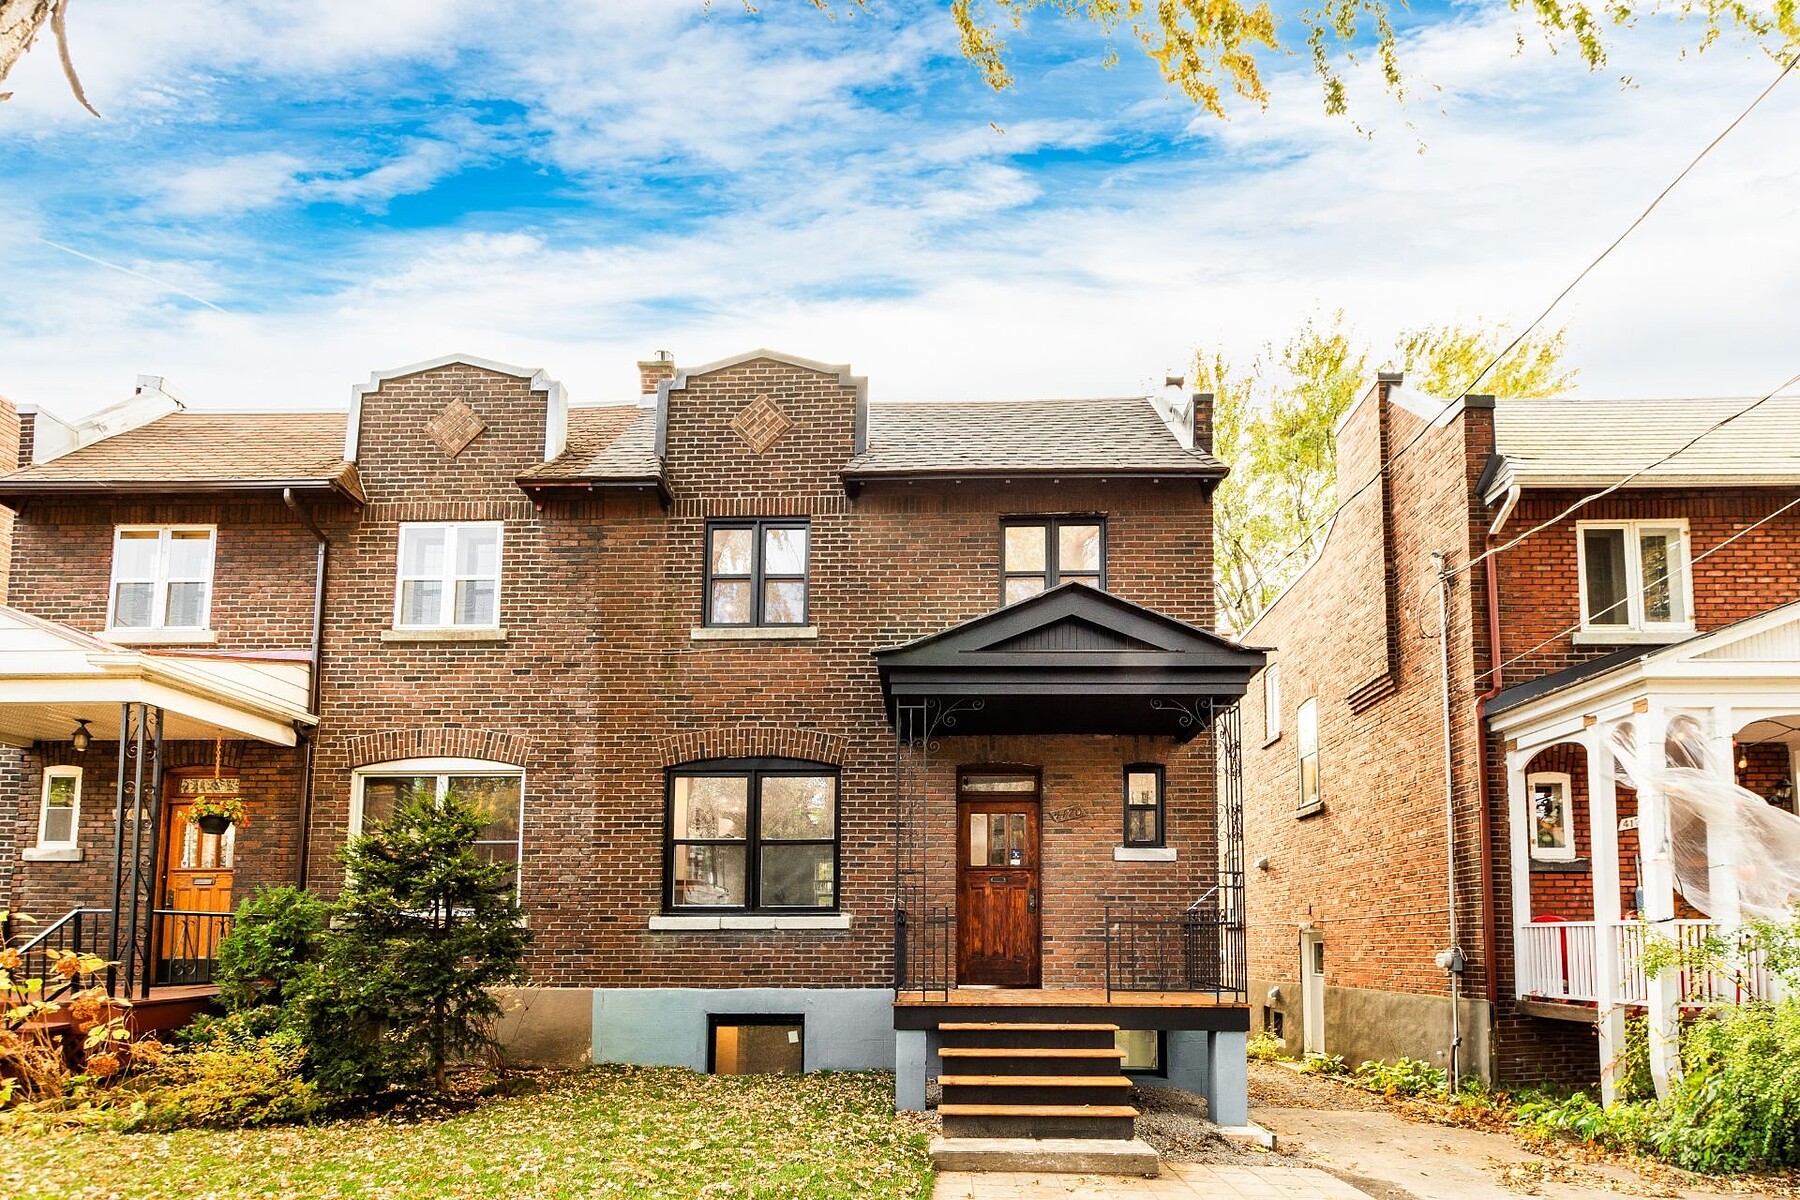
[157,788,238,984]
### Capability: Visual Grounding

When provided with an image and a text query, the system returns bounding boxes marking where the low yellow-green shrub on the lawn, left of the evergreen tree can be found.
[126,1031,322,1130]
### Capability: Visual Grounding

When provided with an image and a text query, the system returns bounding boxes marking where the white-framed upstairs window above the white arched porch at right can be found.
[1575,520,1694,633]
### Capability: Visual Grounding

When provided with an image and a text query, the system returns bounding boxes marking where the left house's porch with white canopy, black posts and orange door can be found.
[0,606,317,1024]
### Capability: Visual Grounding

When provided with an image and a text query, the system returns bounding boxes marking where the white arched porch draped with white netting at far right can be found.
[1489,604,1800,1101]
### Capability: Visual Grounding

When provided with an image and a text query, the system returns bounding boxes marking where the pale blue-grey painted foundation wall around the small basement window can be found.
[594,988,896,1072]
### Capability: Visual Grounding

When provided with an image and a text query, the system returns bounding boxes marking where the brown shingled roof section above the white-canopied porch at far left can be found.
[0,412,364,502]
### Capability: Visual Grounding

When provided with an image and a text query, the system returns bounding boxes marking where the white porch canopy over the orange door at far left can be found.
[0,604,319,747]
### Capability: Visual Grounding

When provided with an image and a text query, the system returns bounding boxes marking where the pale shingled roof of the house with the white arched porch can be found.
[1494,396,1800,491]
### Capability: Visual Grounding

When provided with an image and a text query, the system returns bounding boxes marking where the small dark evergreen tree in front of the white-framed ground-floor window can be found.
[327,790,531,1092]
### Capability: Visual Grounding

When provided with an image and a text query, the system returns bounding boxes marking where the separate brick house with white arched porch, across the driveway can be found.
[1244,374,1800,1096]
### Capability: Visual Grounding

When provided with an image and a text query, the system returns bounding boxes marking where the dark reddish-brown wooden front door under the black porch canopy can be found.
[956,774,1042,988]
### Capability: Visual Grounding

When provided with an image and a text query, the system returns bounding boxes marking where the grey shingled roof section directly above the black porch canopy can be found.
[844,396,1226,479]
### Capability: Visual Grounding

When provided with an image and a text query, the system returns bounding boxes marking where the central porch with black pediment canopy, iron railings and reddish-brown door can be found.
[877,583,1264,1124]
